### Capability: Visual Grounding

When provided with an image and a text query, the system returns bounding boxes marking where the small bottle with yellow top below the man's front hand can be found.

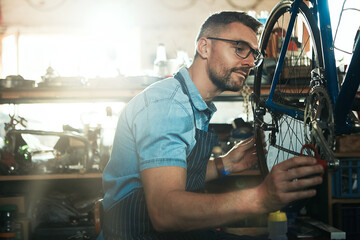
[268,211,288,240]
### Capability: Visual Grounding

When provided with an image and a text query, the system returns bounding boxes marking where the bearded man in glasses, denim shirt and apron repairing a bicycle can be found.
[103,12,323,239]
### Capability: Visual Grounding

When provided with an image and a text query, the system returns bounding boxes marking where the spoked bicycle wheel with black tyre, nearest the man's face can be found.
[253,1,327,177]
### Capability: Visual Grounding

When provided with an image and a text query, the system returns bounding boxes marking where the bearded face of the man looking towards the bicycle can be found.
[208,23,258,91]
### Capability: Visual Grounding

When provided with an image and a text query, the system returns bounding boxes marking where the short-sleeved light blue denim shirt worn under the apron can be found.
[103,67,216,210]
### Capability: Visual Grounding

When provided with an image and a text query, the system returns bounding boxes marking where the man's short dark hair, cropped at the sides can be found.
[195,11,262,57]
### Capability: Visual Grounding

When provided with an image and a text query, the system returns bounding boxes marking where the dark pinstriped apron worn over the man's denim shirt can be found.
[102,73,264,240]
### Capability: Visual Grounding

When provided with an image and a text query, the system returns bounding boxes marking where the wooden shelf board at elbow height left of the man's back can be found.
[0,173,102,182]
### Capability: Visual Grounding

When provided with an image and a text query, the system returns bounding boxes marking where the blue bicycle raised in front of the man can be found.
[251,0,360,176]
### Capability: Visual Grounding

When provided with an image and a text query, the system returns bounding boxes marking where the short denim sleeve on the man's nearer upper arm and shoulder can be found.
[132,95,195,171]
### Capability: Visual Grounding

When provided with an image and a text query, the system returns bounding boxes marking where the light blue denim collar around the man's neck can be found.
[179,67,217,113]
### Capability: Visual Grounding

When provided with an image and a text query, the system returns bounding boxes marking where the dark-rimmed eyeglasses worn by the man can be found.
[207,37,264,67]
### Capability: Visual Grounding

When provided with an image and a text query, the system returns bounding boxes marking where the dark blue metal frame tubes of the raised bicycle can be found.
[266,0,360,134]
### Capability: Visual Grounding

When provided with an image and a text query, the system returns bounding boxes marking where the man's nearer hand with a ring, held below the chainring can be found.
[259,156,324,212]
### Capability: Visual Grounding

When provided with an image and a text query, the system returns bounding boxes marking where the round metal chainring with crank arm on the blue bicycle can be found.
[304,85,339,169]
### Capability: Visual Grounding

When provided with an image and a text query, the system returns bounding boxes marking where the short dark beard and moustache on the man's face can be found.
[209,67,249,92]
